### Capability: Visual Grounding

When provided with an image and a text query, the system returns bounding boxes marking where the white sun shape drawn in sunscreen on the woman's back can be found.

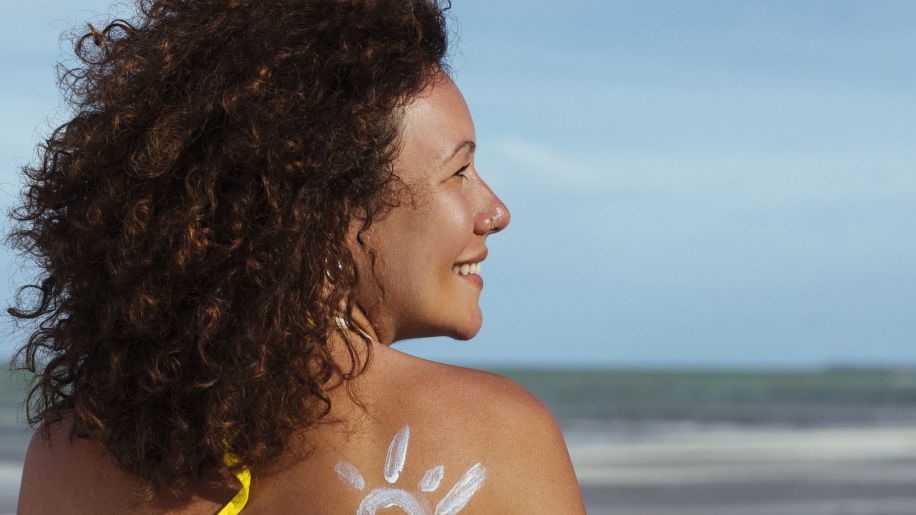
[334,426,487,515]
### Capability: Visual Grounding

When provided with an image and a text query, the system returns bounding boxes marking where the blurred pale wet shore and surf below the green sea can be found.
[0,427,916,515]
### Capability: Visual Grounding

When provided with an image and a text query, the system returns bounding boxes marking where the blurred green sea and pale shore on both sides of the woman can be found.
[0,367,916,515]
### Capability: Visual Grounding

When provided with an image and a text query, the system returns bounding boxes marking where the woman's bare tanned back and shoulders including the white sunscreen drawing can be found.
[20,346,583,514]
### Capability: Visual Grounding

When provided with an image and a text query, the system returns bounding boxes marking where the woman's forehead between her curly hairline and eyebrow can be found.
[401,75,475,167]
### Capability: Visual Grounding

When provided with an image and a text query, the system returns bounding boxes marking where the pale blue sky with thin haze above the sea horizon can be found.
[0,0,916,367]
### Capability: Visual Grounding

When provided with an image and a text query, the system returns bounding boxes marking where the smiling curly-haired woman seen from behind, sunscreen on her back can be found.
[10,0,584,514]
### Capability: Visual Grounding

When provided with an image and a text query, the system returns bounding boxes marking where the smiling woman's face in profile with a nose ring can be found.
[348,75,509,343]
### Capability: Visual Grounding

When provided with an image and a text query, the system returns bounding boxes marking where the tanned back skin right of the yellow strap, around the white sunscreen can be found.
[240,328,584,514]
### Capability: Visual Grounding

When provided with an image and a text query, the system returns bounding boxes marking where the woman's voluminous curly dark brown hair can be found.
[7,0,450,501]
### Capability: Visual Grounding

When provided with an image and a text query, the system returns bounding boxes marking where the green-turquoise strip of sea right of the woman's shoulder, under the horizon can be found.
[490,369,916,429]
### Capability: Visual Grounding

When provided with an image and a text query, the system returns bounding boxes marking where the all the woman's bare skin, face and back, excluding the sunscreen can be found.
[19,76,585,515]
